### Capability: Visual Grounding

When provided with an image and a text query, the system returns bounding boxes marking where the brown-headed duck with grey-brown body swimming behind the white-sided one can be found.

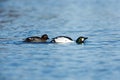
[24,34,49,42]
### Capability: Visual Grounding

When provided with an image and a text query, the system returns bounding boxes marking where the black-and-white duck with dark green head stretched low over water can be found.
[51,36,88,44]
